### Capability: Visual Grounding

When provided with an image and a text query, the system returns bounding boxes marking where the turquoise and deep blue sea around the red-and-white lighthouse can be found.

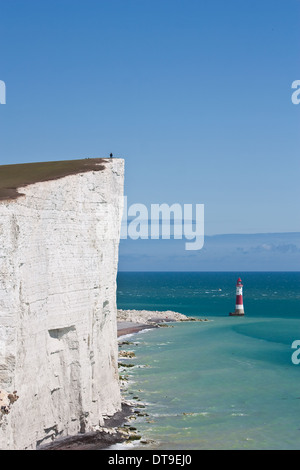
[115,272,300,450]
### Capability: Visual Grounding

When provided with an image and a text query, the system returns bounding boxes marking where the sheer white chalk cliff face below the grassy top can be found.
[0,159,123,449]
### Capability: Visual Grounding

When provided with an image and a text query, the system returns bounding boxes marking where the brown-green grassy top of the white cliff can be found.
[0,158,110,201]
